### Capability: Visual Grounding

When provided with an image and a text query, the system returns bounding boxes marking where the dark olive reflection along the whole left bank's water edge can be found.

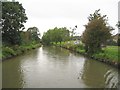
[2,50,37,88]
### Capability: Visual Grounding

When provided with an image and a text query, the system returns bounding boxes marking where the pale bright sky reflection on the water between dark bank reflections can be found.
[21,47,86,88]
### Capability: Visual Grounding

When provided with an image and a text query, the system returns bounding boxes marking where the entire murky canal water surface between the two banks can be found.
[0,46,118,88]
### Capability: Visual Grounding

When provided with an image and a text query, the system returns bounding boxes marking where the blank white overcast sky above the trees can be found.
[16,0,120,35]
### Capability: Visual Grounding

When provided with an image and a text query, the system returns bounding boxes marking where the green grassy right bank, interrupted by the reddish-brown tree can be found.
[54,41,120,66]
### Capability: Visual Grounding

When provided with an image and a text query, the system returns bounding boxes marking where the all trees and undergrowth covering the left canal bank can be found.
[0,1,41,60]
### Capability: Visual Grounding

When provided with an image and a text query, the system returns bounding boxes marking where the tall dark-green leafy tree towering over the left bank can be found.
[2,2,27,45]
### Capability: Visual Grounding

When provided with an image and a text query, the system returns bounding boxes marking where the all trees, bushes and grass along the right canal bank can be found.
[42,9,120,67]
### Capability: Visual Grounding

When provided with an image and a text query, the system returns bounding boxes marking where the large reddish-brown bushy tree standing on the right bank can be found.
[82,9,113,54]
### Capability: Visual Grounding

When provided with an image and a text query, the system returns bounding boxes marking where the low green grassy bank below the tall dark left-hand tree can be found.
[0,44,41,60]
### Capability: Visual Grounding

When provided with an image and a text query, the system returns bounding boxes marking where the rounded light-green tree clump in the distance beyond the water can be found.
[42,27,70,45]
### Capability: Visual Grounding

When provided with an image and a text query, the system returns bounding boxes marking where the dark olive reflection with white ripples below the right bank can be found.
[81,60,118,88]
